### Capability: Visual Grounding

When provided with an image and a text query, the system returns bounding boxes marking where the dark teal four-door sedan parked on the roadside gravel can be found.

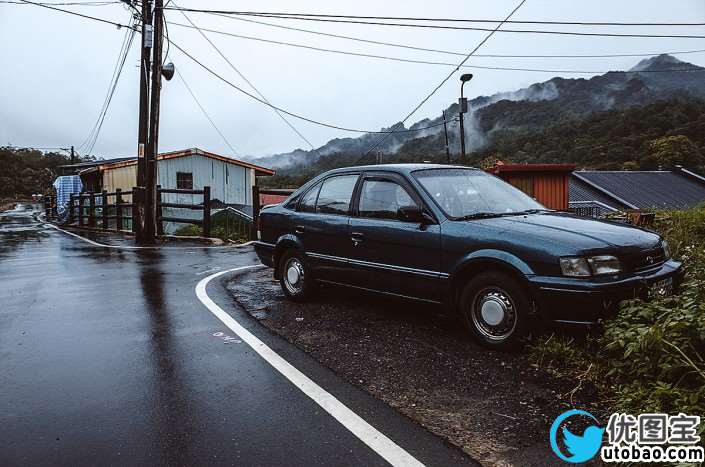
[255,164,682,348]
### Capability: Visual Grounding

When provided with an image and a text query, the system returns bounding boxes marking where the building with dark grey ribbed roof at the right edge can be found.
[569,167,705,215]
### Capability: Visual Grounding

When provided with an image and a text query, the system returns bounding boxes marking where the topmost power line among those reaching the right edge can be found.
[160,9,705,26]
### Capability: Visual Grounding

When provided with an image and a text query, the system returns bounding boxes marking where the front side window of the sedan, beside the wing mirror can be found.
[358,180,416,219]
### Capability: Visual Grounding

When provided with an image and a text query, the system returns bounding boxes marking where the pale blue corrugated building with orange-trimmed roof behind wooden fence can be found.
[69,148,274,233]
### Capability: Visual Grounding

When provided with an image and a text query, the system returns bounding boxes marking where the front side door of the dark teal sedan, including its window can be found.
[349,173,441,301]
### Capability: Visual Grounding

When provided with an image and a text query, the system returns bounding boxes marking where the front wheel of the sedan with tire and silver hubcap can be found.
[459,271,532,350]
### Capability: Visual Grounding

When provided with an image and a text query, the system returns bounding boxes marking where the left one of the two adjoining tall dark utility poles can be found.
[132,0,154,243]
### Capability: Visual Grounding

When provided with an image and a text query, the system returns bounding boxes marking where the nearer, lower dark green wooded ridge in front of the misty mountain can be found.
[262,99,705,186]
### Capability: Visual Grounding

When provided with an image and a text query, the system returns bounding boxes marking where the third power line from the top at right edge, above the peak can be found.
[204,13,705,58]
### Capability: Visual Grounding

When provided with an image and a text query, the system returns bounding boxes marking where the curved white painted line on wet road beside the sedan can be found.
[196,265,423,467]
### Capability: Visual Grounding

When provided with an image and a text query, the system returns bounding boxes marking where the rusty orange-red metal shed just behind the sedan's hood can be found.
[488,162,575,211]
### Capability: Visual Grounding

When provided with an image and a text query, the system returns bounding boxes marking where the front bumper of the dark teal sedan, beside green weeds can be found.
[528,260,683,324]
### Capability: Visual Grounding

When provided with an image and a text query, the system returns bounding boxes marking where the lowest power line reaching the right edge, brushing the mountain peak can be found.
[169,21,705,74]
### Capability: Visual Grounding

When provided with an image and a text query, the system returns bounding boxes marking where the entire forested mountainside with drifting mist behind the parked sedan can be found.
[257,55,705,186]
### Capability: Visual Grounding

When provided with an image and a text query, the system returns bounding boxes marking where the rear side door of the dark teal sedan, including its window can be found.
[292,173,359,282]
